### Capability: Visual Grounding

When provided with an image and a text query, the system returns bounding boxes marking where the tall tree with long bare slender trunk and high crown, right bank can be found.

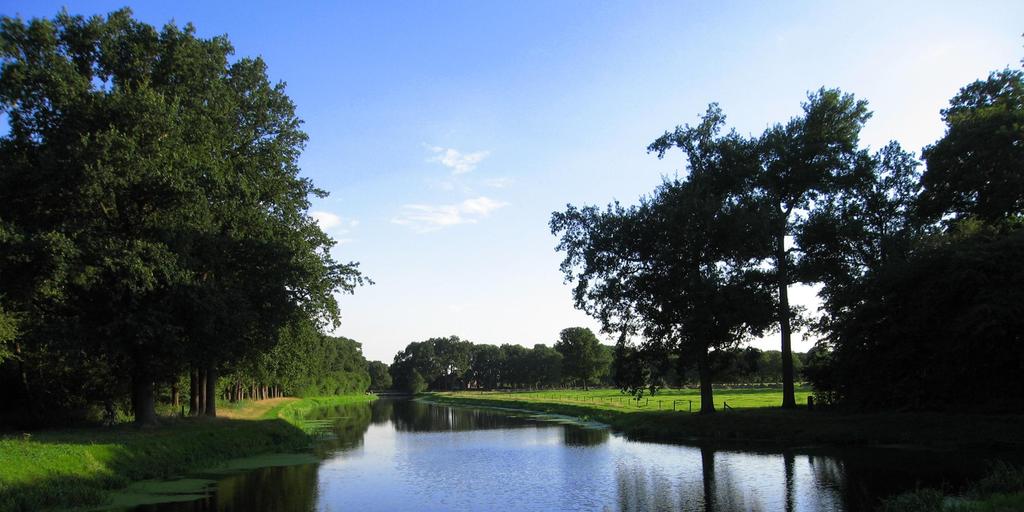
[647,92,870,407]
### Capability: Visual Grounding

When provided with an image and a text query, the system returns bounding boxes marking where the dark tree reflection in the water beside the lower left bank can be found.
[134,464,317,512]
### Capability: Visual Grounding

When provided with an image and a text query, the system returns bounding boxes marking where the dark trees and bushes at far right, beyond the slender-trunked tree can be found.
[797,60,1024,411]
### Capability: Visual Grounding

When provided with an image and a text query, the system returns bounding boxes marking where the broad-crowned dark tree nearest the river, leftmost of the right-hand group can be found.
[551,105,774,414]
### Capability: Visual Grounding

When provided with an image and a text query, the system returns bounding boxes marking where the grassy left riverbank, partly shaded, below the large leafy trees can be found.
[0,395,375,512]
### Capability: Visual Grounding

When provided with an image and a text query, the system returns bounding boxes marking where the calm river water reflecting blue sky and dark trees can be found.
[125,399,984,512]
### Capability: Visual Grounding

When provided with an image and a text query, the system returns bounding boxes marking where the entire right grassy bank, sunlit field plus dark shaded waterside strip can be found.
[426,389,1024,451]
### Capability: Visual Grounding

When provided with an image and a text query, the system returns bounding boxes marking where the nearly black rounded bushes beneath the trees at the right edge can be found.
[812,229,1024,411]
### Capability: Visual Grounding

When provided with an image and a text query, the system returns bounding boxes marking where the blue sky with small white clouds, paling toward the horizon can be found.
[0,0,1024,361]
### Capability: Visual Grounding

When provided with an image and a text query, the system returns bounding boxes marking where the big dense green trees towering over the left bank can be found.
[0,9,362,423]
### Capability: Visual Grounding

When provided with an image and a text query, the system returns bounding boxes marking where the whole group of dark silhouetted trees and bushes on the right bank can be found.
[551,58,1024,413]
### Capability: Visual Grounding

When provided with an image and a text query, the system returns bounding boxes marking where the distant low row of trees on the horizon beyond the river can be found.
[389,328,611,392]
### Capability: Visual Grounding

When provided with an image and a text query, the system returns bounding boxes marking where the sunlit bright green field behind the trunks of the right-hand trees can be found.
[438,387,811,413]
